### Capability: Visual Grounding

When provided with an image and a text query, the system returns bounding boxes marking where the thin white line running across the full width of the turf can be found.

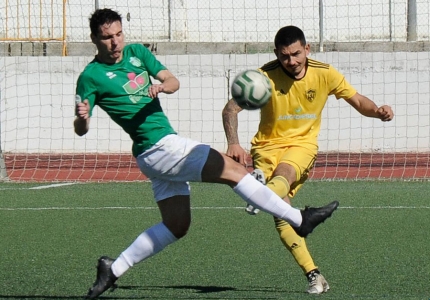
[0,206,430,211]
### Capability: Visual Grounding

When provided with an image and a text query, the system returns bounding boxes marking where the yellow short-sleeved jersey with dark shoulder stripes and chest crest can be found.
[251,58,356,148]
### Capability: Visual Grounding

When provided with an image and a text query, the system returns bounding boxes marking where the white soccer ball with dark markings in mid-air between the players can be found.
[231,70,272,110]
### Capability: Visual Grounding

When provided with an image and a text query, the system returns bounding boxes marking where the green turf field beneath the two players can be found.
[0,181,430,300]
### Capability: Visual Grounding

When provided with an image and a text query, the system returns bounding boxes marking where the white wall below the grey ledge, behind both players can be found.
[0,52,430,153]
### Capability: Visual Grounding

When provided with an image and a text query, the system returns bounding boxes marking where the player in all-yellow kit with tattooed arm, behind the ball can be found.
[223,26,394,294]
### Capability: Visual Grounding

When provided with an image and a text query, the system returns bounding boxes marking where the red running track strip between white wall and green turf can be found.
[4,153,430,182]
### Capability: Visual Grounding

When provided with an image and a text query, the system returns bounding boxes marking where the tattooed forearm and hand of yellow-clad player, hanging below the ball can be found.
[222,99,247,165]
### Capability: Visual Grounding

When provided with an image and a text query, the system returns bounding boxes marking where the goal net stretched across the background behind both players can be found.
[0,0,430,181]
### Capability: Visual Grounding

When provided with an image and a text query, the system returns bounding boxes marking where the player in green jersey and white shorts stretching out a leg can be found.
[74,9,339,299]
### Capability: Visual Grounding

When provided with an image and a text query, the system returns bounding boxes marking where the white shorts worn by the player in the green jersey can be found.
[136,134,210,201]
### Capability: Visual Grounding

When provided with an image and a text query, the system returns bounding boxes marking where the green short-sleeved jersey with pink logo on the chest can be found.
[76,44,176,157]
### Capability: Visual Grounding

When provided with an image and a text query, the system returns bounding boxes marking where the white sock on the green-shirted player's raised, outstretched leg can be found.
[233,174,302,227]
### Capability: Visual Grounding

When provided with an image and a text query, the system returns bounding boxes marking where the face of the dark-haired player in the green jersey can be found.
[91,21,125,64]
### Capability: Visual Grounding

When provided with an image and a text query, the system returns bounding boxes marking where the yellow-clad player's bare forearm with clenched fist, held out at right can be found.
[345,93,394,122]
